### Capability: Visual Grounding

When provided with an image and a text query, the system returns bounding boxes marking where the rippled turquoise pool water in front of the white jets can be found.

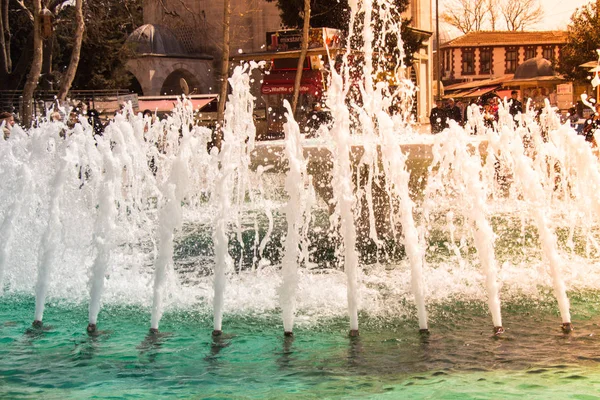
[0,292,600,399]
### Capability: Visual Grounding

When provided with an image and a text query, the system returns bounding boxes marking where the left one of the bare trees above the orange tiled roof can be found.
[440,0,488,33]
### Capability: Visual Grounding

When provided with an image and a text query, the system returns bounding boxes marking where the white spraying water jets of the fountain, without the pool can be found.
[0,2,600,346]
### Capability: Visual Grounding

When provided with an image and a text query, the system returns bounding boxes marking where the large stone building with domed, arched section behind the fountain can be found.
[127,0,433,121]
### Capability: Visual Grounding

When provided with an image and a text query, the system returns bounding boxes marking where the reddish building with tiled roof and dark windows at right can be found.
[440,31,573,109]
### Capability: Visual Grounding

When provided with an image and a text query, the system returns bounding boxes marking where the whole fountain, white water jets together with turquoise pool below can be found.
[5,2,600,397]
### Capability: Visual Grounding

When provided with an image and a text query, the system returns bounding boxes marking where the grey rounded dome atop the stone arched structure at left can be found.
[125,24,185,55]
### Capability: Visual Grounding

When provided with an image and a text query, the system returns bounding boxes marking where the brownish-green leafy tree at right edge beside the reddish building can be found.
[559,3,600,82]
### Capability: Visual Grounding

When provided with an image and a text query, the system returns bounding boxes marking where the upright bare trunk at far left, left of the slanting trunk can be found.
[21,0,43,127]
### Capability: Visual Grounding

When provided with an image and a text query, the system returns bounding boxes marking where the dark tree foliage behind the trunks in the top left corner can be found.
[0,0,143,89]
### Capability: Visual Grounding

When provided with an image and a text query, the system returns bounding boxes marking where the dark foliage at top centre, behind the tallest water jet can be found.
[266,0,421,65]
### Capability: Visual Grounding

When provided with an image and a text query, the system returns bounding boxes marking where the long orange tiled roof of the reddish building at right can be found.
[440,31,567,48]
